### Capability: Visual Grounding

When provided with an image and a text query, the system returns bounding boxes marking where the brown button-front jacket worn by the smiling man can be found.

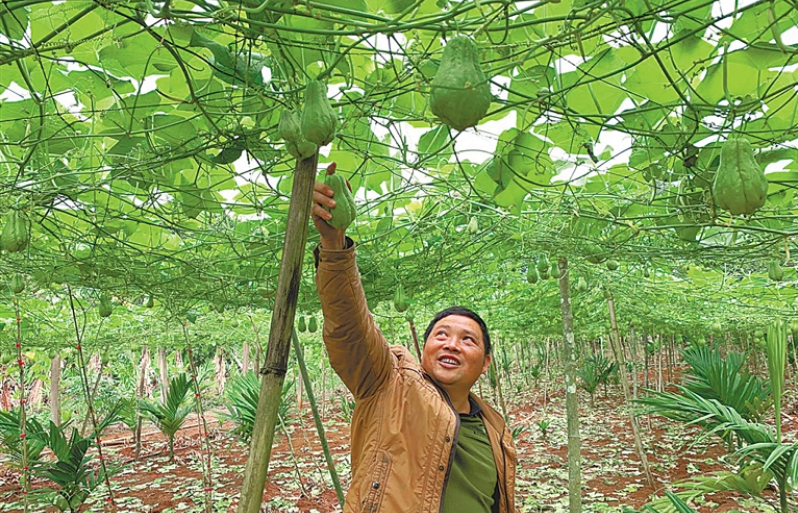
[316,245,516,513]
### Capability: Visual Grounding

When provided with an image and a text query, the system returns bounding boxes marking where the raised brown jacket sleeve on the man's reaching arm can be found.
[314,238,393,400]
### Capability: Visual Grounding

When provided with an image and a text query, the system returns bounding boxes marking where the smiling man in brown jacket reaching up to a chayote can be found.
[312,176,516,513]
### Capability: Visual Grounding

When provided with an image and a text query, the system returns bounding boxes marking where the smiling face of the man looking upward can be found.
[421,315,490,395]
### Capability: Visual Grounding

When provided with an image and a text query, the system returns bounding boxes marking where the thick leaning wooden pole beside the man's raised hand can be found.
[238,153,318,513]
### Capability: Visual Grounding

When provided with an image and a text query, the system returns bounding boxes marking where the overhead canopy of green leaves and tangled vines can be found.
[0,0,798,348]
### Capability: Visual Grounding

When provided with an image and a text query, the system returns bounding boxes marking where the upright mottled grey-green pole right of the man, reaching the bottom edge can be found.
[557,257,582,513]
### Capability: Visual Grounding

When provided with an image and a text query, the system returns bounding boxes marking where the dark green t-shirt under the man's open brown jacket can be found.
[443,402,498,513]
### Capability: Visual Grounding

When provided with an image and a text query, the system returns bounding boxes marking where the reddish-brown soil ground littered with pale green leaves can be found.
[0,370,798,513]
